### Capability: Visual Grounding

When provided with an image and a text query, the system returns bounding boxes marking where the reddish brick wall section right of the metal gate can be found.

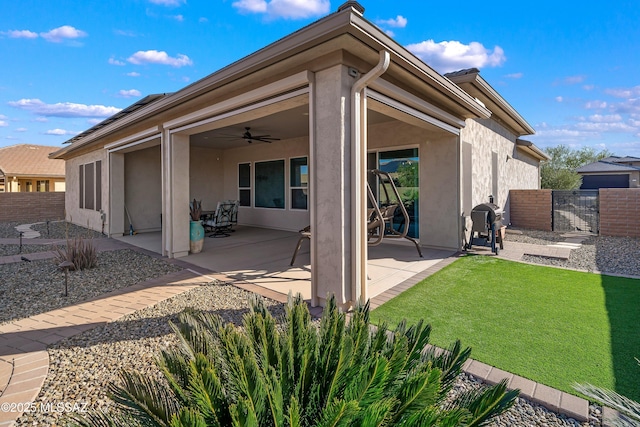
[600,188,640,237]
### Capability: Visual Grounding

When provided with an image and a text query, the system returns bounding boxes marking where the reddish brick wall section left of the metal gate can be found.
[509,190,552,231]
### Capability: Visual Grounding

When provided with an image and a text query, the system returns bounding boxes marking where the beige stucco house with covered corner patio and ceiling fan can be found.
[53,2,545,306]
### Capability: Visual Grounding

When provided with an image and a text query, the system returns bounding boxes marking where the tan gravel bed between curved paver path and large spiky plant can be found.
[17,282,284,426]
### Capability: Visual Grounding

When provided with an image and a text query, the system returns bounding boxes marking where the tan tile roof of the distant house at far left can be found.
[0,144,65,178]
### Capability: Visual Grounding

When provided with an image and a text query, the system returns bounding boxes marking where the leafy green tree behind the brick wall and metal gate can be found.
[540,145,613,190]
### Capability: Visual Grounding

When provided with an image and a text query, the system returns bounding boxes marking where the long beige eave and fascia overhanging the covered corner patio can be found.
[52,2,496,159]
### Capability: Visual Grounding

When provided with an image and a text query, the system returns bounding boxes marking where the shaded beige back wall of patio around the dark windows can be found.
[221,137,308,231]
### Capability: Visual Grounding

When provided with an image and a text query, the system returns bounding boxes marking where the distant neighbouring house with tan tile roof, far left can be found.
[0,144,65,193]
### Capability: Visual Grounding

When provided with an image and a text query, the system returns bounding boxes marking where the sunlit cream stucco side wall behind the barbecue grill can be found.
[460,119,540,224]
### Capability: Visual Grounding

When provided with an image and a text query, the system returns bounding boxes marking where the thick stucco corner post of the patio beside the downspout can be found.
[310,65,357,306]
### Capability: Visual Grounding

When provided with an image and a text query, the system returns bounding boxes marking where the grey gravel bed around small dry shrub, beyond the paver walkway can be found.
[0,249,180,323]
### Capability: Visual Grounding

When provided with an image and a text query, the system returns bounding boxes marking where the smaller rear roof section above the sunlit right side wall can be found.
[445,68,536,136]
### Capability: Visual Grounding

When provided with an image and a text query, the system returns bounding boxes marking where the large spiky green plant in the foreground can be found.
[75,295,518,427]
